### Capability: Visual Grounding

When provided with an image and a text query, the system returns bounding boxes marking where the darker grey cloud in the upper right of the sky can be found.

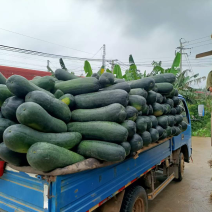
[99,0,212,39]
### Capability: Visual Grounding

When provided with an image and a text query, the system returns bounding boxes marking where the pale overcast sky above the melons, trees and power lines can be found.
[0,0,212,86]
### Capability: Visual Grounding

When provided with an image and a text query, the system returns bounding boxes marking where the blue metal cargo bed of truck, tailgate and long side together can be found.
[0,139,172,212]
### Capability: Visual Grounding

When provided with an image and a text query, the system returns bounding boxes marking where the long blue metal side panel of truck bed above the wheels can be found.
[51,140,172,212]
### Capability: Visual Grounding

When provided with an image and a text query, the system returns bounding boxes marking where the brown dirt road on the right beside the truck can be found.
[149,137,212,212]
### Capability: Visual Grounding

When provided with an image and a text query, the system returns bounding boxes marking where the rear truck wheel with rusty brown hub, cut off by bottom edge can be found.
[120,186,148,212]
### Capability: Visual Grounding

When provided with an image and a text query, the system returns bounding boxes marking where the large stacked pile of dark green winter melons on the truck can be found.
[0,69,187,172]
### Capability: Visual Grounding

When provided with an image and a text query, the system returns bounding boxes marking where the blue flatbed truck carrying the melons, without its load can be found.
[0,95,192,212]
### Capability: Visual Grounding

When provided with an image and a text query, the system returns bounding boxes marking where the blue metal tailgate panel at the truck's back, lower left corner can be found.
[0,170,45,212]
